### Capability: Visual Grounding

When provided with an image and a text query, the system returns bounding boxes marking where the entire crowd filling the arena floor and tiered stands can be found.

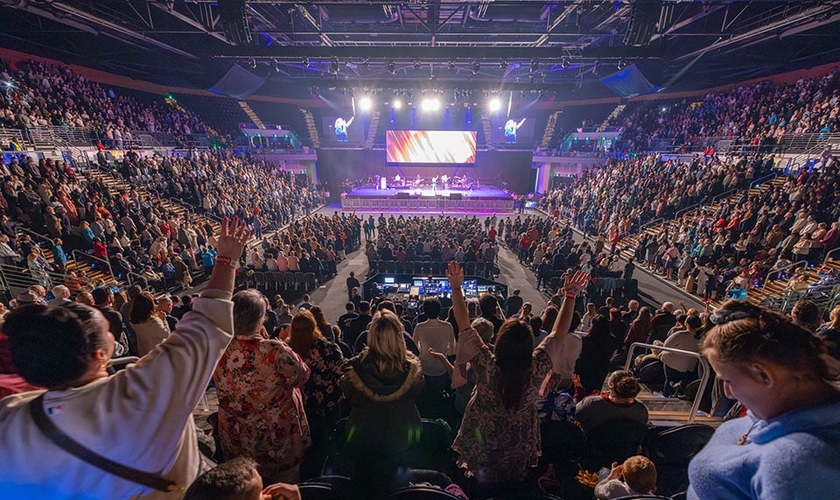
[0,54,840,500]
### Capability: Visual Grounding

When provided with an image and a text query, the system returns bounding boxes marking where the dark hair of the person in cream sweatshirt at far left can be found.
[2,302,107,389]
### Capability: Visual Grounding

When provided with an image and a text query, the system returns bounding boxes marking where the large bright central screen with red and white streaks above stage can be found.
[385,130,475,164]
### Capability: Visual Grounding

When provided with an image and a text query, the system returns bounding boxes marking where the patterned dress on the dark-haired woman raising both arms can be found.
[452,329,551,483]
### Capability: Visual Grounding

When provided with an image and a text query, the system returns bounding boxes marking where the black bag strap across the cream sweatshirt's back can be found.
[29,394,181,491]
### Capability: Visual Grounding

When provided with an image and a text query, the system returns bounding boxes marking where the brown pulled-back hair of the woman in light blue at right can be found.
[701,300,840,381]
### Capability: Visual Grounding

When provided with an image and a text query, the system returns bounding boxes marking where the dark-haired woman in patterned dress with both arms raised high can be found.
[446,262,588,486]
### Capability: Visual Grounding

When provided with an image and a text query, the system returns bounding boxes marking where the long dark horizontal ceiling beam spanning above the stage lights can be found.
[213,46,664,61]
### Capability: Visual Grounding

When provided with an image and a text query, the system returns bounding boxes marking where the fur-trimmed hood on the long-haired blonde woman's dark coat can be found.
[341,349,424,403]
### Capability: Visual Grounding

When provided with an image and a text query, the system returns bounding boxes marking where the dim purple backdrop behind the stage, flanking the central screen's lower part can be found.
[318,148,536,201]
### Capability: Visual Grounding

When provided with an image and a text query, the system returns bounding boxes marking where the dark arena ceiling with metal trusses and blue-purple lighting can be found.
[0,0,840,99]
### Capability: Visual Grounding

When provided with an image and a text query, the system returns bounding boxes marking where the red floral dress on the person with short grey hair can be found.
[213,337,309,478]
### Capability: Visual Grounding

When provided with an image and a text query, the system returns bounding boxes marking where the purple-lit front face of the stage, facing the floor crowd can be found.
[341,196,514,213]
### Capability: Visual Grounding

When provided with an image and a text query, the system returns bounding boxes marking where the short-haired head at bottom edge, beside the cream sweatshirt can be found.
[184,457,263,500]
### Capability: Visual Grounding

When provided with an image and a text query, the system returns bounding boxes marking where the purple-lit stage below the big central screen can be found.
[341,185,515,213]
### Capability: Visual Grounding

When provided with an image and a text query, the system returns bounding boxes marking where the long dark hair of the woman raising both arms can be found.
[495,318,534,411]
